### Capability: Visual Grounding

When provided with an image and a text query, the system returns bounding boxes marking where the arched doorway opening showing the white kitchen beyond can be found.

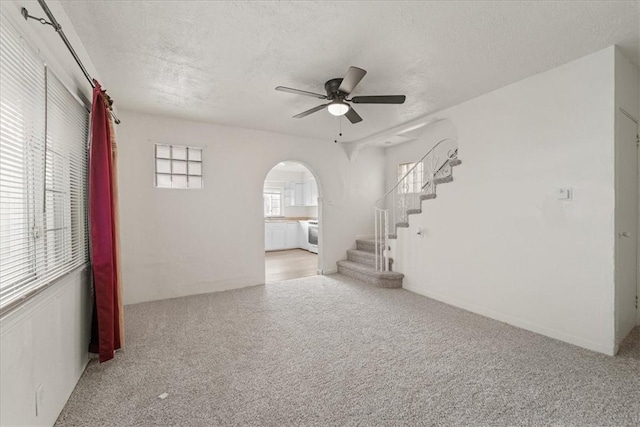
[262,161,322,283]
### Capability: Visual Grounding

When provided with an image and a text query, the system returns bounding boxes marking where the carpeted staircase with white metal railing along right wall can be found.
[338,138,462,288]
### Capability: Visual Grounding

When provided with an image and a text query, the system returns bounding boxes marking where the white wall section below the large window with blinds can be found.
[0,271,91,426]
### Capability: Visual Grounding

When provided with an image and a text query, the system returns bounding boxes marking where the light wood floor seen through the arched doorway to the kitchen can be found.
[264,249,318,283]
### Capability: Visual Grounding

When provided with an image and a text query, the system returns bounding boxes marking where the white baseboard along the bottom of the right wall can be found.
[404,285,619,356]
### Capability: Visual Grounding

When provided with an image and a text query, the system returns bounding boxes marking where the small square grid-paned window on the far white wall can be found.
[156,144,202,189]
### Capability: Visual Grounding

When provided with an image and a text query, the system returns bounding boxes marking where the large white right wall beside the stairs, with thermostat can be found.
[387,47,614,354]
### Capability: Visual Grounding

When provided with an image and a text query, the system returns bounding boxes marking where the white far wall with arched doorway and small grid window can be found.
[118,111,384,304]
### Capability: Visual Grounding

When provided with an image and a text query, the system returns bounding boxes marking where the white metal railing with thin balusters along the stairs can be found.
[374,138,458,271]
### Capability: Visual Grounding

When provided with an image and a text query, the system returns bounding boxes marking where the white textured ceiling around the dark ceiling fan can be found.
[61,0,640,141]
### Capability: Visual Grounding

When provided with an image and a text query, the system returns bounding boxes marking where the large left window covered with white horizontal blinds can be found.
[0,17,89,312]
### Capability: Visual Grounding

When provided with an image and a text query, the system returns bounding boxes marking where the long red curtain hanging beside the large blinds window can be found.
[89,80,123,363]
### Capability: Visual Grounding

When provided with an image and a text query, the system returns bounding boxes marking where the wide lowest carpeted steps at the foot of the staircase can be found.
[338,239,404,288]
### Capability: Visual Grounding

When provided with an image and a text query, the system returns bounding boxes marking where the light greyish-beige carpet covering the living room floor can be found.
[56,275,640,426]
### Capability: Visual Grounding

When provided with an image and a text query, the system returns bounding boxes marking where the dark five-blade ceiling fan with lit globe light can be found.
[276,67,406,123]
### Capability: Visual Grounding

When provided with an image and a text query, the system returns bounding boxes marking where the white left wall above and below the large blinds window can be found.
[0,0,100,426]
